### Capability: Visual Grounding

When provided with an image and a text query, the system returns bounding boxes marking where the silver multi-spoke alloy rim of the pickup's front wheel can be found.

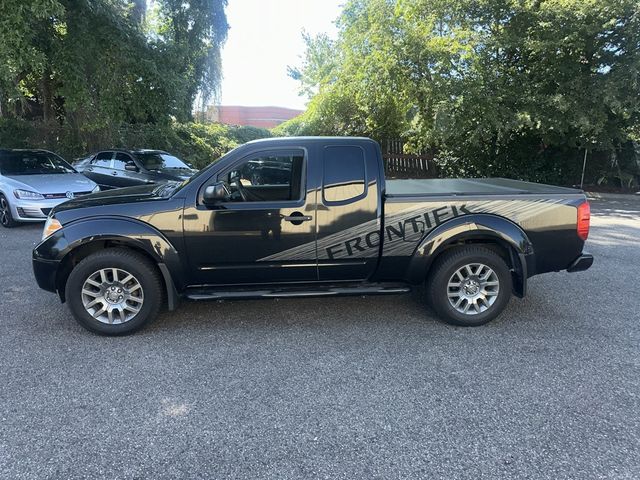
[82,268,144,325]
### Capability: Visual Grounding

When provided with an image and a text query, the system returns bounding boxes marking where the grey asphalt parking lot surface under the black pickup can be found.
[0,198,640,479]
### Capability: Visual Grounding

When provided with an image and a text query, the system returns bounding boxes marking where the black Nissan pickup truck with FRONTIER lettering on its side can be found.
[33,137,593,334]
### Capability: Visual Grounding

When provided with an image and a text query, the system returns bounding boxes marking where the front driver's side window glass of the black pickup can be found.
[218,151,304,202]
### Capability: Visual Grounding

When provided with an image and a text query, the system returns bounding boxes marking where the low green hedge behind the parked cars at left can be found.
[0,119,271,168]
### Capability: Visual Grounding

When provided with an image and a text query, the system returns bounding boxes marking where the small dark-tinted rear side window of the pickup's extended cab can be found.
[322,146,366,203]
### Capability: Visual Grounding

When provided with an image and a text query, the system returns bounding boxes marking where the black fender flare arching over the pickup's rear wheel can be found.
[406,214,535,295]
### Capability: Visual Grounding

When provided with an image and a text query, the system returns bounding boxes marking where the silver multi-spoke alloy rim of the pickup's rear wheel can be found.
[447,263,500,315]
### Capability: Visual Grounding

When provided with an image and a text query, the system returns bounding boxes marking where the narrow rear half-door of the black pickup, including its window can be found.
[317,142,381,281]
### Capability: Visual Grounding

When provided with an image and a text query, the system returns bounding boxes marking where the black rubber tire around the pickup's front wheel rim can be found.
[65,248,164,335]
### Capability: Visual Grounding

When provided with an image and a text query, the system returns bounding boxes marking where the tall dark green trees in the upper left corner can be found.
[0,0,228,124]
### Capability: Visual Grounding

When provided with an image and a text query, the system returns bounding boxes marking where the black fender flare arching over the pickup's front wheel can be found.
[33,216,184,294]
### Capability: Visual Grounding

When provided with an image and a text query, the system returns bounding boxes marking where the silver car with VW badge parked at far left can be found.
[0,150,100,228]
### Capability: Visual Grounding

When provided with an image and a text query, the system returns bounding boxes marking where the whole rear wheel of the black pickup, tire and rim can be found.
[427,246,512,327]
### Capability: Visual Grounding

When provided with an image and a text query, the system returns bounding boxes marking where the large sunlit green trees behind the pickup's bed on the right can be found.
[288,0,640,183]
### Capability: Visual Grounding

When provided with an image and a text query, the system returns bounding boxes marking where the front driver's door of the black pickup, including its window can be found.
[184,148,318,285]
